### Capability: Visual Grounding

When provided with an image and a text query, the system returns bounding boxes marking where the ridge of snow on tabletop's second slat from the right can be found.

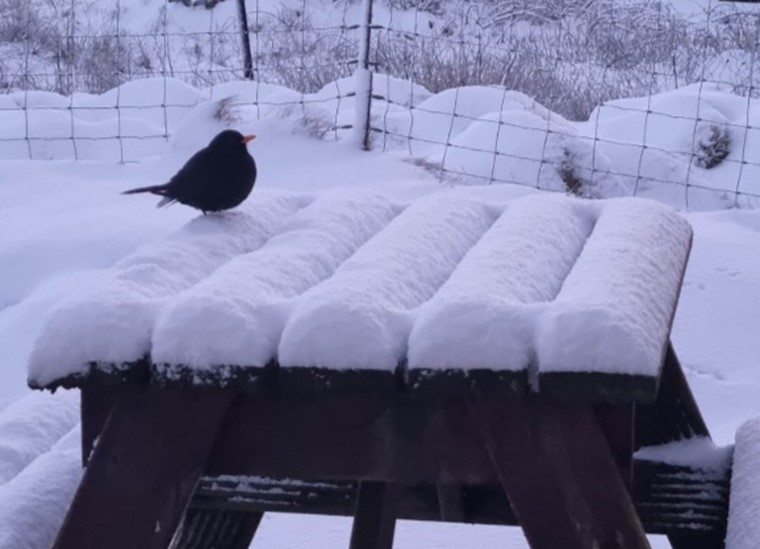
[409,195,594,370]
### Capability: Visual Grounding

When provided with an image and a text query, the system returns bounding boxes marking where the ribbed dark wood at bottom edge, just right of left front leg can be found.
[170,508,264,549]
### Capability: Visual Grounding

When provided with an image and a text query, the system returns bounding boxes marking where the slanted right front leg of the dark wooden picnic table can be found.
[470,399,649,549]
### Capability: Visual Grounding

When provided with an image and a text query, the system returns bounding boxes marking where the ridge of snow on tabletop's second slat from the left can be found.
[152,190,400,373]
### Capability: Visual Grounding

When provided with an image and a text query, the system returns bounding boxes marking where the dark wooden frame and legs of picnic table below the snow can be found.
[47,334,728,549]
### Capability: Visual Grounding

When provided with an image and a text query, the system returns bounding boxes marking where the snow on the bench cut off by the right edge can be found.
[726,418,760,549]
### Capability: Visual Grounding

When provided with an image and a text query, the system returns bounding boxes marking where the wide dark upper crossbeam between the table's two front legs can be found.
[207,394,496,484]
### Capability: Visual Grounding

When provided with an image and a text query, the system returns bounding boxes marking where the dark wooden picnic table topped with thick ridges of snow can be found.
[29,190,727,549]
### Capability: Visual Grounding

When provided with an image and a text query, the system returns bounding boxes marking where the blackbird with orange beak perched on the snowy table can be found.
[121,130,256,215]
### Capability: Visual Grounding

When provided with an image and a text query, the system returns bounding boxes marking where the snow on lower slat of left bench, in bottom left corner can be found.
[0,427,83,549]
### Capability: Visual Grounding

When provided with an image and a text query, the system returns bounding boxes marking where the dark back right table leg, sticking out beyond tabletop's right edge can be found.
[636,345,710,449]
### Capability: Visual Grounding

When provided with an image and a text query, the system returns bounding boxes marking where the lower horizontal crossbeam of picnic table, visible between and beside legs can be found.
[190,460,730,539]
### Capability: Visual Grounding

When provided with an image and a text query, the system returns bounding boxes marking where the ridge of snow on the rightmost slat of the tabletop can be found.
[536,198,691,376]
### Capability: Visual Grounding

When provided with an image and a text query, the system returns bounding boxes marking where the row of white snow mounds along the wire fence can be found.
[0,74,760,210]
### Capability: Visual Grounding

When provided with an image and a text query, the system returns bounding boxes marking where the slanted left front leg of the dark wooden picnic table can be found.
[54,386,234,549]
